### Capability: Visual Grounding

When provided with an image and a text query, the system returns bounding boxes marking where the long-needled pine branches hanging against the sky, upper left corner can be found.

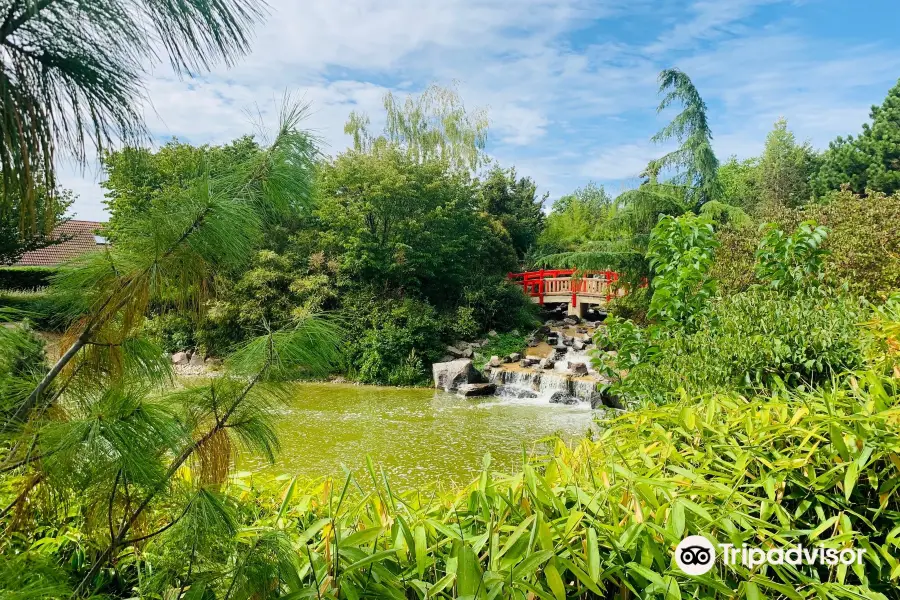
[0,0,265,231]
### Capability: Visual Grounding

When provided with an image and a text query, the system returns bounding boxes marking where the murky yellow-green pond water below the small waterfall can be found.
[240,383,592,489]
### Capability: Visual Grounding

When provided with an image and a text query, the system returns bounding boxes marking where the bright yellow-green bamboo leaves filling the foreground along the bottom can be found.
[72,373,900,600]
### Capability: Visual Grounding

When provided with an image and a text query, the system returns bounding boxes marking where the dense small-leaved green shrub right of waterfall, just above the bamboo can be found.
[598,288,867,403]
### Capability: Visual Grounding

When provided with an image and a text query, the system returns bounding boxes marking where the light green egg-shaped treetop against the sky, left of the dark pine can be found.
[759,118,815,207]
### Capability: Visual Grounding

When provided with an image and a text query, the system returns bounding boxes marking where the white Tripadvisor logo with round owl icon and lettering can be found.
[675,535,866,575]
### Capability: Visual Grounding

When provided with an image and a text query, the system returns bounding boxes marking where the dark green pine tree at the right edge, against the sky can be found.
[815,80,900,195]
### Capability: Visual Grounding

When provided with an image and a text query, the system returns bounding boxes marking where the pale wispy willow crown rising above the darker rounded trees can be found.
[344,84,488,171]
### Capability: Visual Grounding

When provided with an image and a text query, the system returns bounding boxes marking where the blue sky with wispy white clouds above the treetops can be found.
[60,0,900,219]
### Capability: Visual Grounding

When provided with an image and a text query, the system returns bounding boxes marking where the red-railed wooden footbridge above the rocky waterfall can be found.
[509,269,625,317]
